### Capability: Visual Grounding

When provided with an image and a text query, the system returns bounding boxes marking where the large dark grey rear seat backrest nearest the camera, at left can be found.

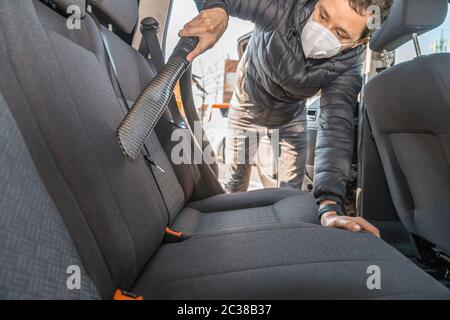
[0,0,169,298]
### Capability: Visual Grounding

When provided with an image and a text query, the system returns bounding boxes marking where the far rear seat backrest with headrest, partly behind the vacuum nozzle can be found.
[88,0,194,222]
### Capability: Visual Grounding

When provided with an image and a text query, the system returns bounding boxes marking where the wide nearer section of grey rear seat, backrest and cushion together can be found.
[0,0,450,299]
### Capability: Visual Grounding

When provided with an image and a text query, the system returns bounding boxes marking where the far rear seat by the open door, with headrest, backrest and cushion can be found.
[88,0,319,234]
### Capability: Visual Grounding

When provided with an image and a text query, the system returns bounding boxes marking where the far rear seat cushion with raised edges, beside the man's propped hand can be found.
[171,189,319,234]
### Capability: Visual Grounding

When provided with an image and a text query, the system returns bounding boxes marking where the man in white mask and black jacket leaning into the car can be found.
[180,0,393,237]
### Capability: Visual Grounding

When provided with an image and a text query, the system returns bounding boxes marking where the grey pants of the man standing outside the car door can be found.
[225,103,307,193]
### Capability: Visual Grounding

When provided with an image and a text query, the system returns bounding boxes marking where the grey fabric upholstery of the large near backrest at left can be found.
[0,1,168,288]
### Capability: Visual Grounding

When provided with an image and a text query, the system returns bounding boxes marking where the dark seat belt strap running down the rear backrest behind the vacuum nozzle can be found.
[91,15,171,219]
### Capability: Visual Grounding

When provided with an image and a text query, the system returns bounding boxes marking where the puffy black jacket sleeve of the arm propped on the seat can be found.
[314,67,362,204]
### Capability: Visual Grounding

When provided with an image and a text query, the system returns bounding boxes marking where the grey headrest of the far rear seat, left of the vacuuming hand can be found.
[88,0,139,34]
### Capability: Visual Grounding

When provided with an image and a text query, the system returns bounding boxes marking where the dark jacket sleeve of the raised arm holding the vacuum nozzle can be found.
[195,0,284,29]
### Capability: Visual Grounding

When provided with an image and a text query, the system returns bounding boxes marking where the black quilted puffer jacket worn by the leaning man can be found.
[197,0,365,203]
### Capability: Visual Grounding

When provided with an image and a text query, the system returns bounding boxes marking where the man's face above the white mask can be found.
[313,0,371,48]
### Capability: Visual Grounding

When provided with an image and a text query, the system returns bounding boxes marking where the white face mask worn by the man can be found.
[301,17,351,59]
